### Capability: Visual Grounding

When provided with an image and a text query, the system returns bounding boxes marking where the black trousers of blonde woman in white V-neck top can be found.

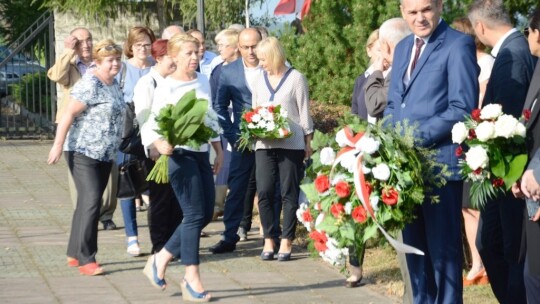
[255,149,304,240]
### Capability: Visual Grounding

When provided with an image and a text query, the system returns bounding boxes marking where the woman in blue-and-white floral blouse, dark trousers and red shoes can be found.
[47,39,125,276]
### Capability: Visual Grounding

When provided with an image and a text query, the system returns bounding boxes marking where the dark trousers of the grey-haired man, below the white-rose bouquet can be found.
[476,193,526,304]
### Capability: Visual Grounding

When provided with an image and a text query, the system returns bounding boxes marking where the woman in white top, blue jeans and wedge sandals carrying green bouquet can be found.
[142,34,223,302]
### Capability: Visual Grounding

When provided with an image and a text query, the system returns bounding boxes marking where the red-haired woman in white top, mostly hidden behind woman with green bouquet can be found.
[135,39,182,253]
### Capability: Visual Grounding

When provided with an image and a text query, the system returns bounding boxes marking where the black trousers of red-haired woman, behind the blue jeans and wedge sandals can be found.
[146,159,184,253]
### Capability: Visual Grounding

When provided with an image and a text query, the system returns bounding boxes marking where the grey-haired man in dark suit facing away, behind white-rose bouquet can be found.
[468,0,535,303]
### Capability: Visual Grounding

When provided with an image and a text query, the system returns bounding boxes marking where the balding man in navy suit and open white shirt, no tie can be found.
[209,28,262,254]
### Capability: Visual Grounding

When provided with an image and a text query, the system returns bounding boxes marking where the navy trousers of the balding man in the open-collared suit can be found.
[223,149,255,244]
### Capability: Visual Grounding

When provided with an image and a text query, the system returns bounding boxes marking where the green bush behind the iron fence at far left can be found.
[10,72,52,113]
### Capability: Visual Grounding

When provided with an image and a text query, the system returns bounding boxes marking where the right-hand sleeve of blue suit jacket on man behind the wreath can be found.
[418,36,479,147]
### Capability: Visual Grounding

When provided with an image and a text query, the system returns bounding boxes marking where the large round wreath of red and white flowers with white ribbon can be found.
[297,117,447,265]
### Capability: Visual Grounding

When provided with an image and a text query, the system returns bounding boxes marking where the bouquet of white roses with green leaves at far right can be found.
[452,104,530,208]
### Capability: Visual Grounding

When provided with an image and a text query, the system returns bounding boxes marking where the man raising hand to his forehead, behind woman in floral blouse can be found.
[47,27,118,230]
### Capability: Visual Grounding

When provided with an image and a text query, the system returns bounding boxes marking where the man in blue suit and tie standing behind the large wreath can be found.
[384,0,479,303]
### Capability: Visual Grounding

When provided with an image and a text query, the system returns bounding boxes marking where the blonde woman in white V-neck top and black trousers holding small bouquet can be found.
[252,37,313,261]
